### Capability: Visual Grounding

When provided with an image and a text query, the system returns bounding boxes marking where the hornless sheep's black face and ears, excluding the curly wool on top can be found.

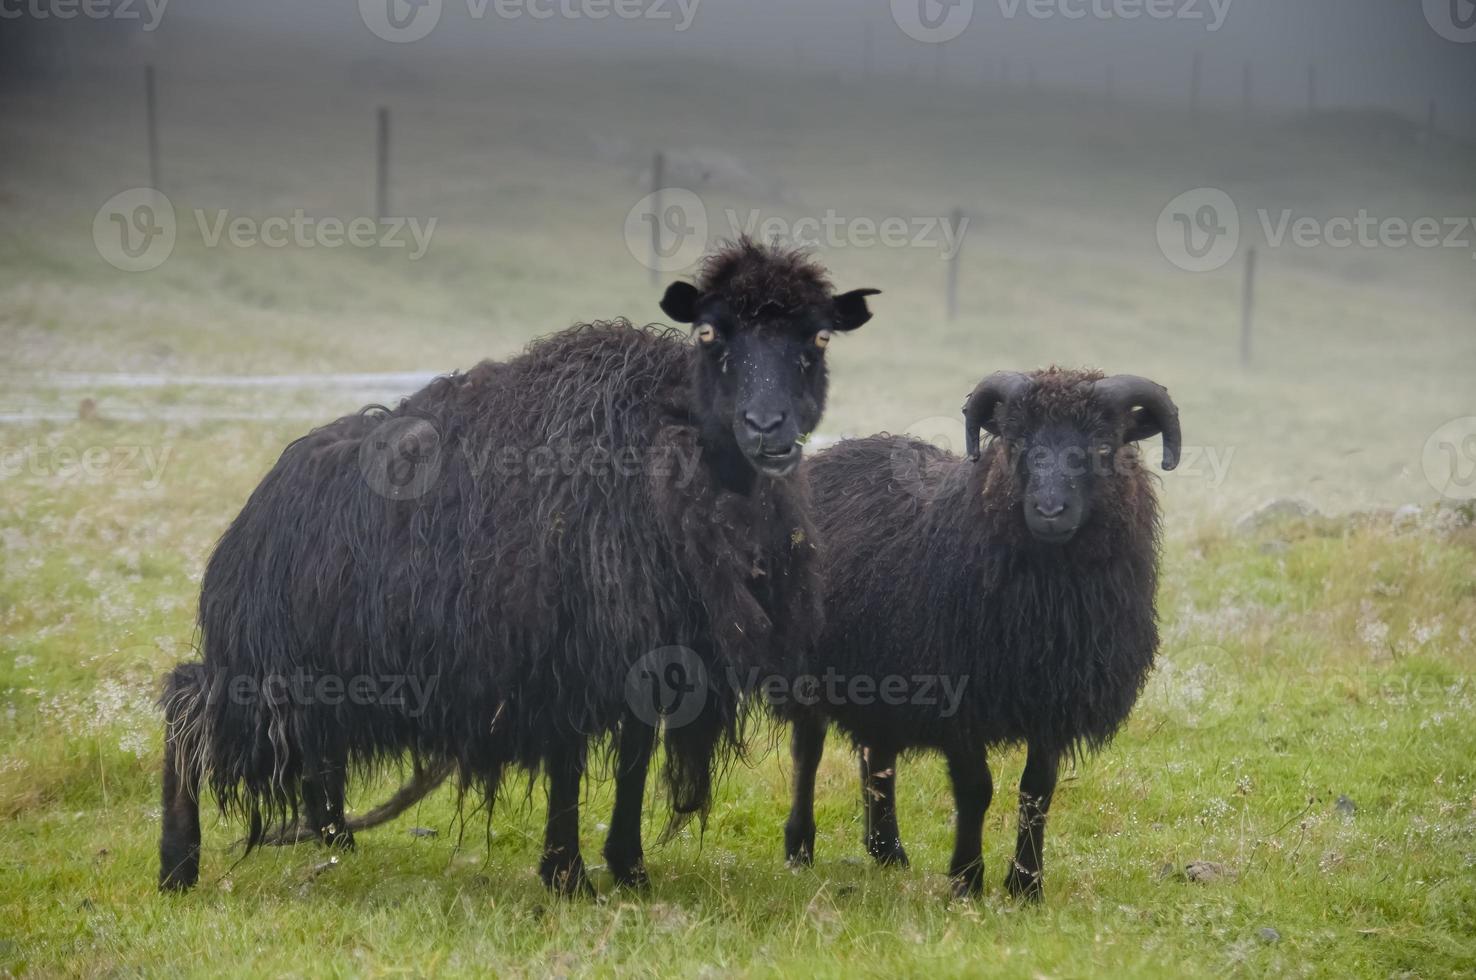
[661,282,874,477]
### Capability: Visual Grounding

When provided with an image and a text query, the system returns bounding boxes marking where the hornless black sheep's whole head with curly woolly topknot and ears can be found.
[661,239,877,477]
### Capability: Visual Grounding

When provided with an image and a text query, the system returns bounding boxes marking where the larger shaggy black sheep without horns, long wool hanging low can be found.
[159,241,874,893]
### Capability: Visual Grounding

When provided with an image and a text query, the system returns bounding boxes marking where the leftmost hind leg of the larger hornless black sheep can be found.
[159,664,208,891]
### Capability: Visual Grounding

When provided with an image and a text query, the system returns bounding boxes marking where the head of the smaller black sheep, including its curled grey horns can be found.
[964,368,1181,545]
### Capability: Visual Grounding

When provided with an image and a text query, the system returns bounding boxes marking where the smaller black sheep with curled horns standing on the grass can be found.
[785,368,1181,899]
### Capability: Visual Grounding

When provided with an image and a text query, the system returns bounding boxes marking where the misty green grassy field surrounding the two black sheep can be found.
[0,34,1476,977]
